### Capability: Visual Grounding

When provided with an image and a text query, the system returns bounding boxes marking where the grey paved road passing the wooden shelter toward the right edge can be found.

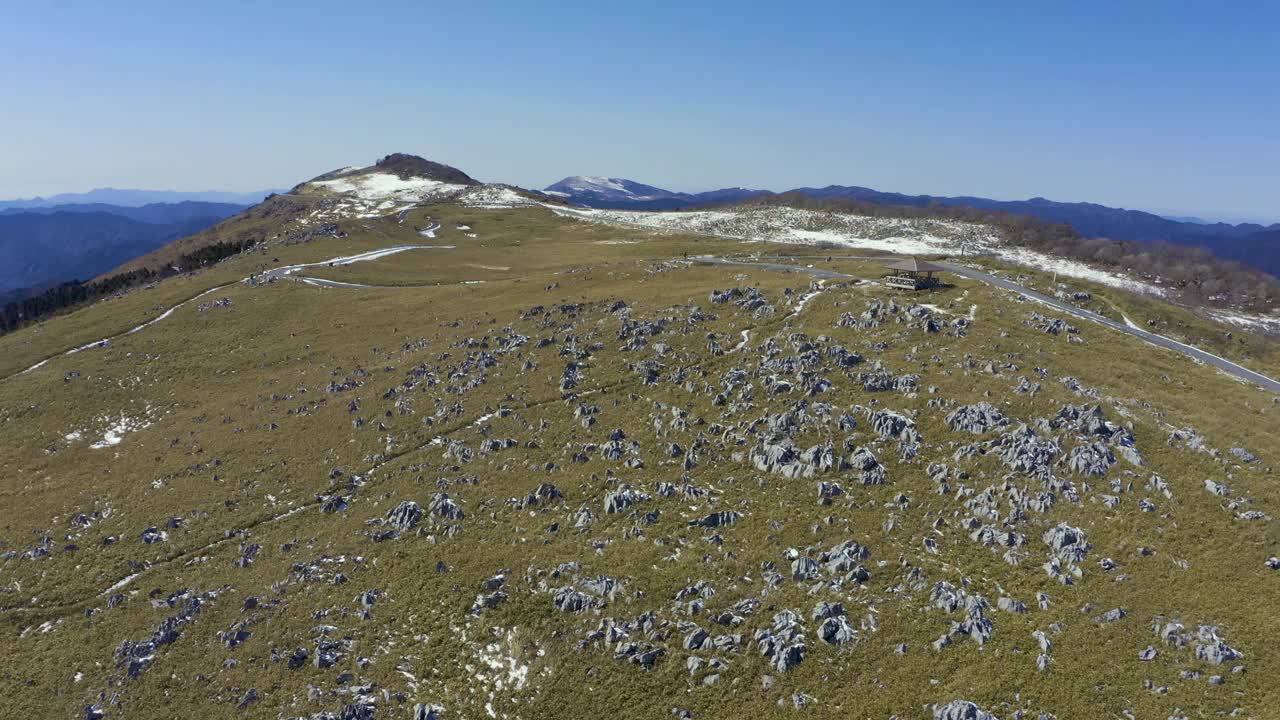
[690,255,1280,393]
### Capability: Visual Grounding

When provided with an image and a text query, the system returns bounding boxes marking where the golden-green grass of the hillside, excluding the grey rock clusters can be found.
[0,205,1280,719]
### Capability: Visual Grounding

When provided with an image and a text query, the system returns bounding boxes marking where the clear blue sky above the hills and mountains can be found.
[0,0,1280,220]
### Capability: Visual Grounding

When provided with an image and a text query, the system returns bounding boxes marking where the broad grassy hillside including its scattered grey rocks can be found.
[0,197,1280,719]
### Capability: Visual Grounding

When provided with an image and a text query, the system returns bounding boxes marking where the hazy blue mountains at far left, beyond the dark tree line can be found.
[0,201,246,305]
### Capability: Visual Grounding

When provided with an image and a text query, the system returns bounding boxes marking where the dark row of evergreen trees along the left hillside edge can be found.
[0,238,257,334]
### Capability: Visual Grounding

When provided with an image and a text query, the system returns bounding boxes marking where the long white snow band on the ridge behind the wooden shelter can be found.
[552,206,1167,296]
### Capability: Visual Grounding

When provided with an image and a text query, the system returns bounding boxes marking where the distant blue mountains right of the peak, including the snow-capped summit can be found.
[544,176,1280,275]
